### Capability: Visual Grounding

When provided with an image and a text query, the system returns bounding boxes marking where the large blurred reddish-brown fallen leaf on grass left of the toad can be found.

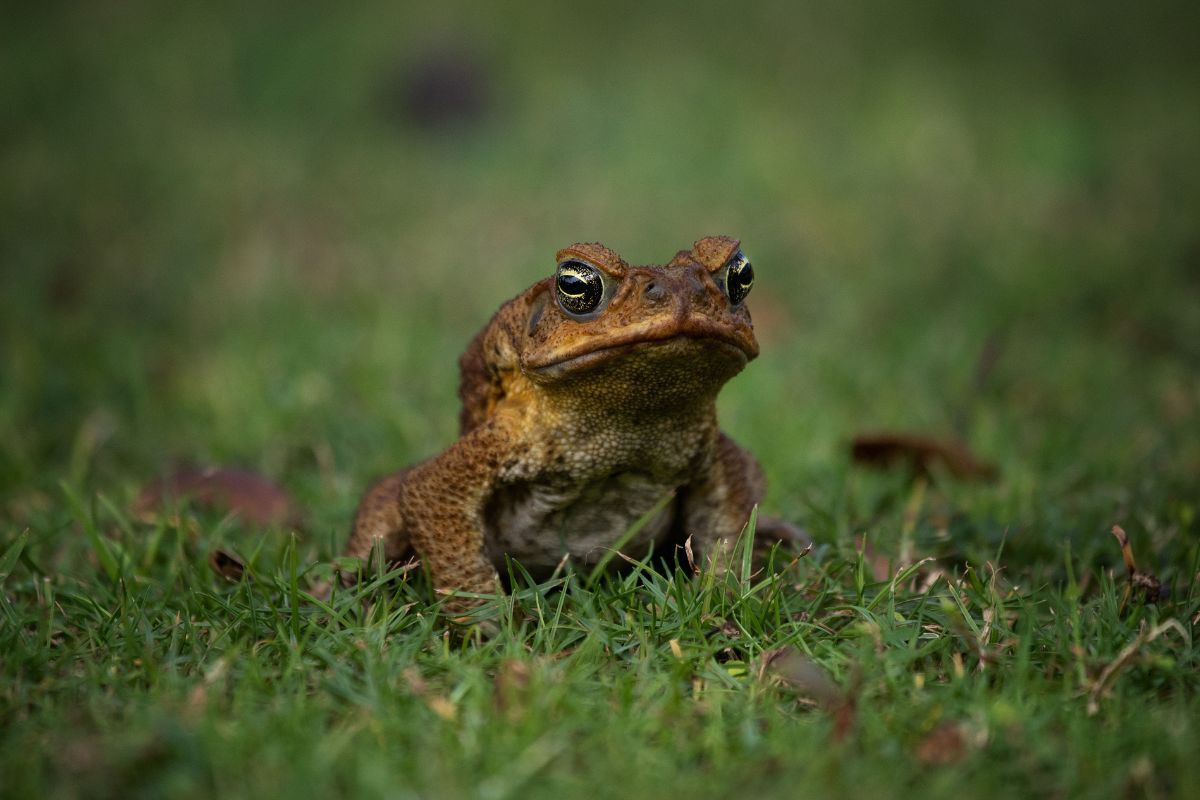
[133,467,300,525]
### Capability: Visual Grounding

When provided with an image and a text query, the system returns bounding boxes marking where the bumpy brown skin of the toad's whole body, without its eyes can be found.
[347,236,802,612]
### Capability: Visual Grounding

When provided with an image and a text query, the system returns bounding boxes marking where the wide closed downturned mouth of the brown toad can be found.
[524,325,758,378]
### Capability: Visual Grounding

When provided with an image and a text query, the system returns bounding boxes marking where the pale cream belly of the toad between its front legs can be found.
[485,471,677,579]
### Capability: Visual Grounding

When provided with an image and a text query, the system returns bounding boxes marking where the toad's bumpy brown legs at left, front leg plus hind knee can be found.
[347,417,512,614]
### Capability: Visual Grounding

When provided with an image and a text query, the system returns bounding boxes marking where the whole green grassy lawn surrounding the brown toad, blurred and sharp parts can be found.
[0,2,1200,798]
